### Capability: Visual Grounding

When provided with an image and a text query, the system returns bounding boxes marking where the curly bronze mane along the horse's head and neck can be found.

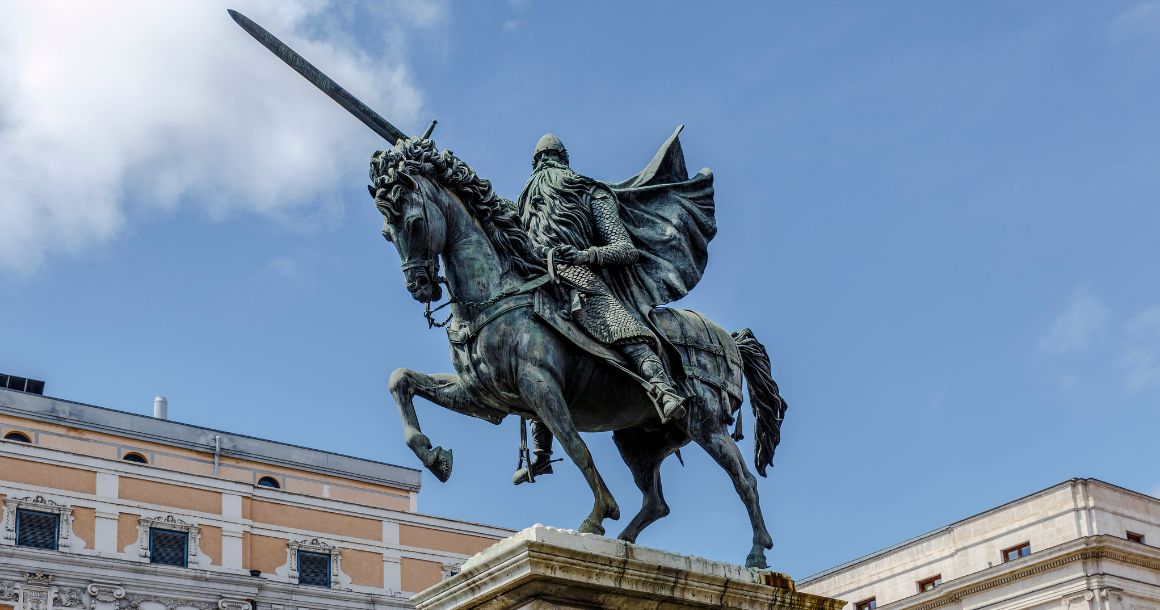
[368,138,545,278]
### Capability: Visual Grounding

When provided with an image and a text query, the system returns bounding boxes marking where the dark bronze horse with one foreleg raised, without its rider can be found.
[369,135,786,568]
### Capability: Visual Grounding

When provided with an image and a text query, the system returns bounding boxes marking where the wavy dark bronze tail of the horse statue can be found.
[732,328,789,477]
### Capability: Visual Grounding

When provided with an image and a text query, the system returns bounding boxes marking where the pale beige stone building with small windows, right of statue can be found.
[798,479,1160,610]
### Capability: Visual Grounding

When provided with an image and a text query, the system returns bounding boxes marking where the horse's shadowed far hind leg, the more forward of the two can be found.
[612,428,676,543]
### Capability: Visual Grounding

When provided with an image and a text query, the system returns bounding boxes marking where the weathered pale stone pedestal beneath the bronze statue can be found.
[412,525,846,610]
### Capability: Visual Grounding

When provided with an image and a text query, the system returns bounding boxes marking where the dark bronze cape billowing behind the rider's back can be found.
[602,125,717,320]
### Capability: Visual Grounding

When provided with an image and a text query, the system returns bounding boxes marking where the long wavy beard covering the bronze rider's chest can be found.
[519,159,593,249]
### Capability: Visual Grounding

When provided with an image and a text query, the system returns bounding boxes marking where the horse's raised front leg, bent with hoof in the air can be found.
[387,369,506,481]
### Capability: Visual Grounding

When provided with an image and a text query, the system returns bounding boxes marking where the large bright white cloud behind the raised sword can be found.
[0,0,442,271]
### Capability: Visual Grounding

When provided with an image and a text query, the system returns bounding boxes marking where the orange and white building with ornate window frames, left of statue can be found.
[0,376,512,610]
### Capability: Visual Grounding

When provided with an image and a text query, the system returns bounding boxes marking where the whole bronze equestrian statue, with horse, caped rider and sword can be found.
[231,12,786,568]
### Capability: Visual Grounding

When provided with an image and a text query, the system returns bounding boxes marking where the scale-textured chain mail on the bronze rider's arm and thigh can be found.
[536,186,655,344]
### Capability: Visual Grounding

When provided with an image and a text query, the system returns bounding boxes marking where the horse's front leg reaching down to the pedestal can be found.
[516,368,621,536]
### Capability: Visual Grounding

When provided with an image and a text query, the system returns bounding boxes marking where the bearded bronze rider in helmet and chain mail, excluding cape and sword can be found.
[516,133,688,482]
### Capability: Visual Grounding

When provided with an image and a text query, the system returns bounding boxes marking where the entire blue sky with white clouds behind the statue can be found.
[0,1,1160,578]
